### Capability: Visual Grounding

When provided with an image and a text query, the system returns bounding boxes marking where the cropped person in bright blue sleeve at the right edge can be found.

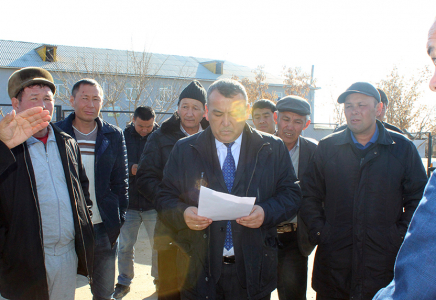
[374,21,436,300]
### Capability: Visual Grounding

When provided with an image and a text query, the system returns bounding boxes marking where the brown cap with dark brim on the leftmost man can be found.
[8,67,56,99]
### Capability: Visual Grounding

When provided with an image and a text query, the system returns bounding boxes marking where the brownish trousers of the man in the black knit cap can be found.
[157,247,180,300]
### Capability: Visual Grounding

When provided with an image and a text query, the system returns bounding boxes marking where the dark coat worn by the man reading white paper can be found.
[157,125,301,300]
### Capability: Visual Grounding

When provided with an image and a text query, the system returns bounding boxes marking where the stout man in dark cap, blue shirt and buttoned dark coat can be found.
[300,82,427,299]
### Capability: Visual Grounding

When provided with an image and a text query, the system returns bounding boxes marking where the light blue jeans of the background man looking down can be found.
[118,209,158,286]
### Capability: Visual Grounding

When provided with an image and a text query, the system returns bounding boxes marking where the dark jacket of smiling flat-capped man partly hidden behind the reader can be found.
[297,136,318,257]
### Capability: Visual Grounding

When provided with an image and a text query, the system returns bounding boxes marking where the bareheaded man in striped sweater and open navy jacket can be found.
[57,78,129,300]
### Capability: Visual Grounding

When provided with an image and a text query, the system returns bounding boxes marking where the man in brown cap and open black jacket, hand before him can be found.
[0,67,94,300]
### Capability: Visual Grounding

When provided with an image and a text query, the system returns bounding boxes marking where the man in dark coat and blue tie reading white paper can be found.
[157,79,301,300]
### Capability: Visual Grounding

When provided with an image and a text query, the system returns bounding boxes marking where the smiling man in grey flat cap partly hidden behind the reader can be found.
[274,95,318,300]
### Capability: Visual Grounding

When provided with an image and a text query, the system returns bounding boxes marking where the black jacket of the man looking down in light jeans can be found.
[124,123,159,211]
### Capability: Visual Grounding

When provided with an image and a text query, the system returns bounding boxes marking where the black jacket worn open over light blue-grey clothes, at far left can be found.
[0,126,94,300]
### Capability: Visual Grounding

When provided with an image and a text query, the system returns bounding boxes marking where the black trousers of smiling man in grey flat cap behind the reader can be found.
[277,231,307,300]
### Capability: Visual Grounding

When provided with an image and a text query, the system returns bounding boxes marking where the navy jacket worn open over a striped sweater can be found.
[56,113,129,246]
